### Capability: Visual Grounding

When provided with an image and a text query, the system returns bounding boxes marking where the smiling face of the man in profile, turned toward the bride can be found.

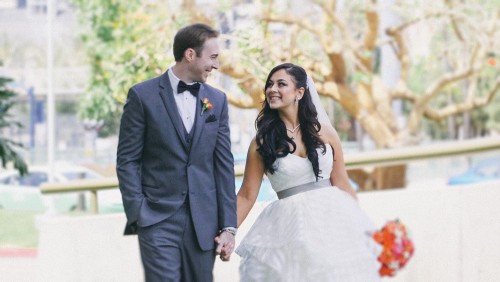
[189,38,219,82]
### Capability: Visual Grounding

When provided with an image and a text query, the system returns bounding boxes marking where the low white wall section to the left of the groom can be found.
[37,214,143,282]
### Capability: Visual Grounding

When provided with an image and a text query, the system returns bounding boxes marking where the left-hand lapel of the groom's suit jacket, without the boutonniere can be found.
[159,72,188,150]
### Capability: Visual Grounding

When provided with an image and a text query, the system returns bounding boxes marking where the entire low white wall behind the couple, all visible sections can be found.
[38,182,500,282]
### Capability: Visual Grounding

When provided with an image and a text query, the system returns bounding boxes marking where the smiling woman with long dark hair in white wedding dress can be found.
[236,64,380,282]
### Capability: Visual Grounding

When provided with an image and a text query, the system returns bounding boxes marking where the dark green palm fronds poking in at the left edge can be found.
[0,77,28,175]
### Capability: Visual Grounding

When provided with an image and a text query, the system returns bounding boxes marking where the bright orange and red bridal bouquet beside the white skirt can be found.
[373,219,415,276]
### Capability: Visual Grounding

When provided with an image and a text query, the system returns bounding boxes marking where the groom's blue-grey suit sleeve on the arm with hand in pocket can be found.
[116,88,145,226]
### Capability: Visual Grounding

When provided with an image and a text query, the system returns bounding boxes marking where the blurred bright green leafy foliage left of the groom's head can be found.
[72,0,176,136]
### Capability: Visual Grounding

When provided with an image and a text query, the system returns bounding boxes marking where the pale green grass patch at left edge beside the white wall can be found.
[0,209,40,249]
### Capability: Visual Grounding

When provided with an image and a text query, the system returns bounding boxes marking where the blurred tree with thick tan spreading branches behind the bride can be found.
[189,0,500,148]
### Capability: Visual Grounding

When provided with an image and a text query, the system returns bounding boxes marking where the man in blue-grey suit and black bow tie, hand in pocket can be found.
[116,24,236,281]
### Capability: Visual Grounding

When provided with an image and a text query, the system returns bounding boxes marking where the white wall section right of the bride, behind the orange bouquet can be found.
[360,182,500,282]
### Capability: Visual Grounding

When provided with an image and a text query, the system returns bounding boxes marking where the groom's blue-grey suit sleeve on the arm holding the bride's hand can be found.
[214,95,236,229]
